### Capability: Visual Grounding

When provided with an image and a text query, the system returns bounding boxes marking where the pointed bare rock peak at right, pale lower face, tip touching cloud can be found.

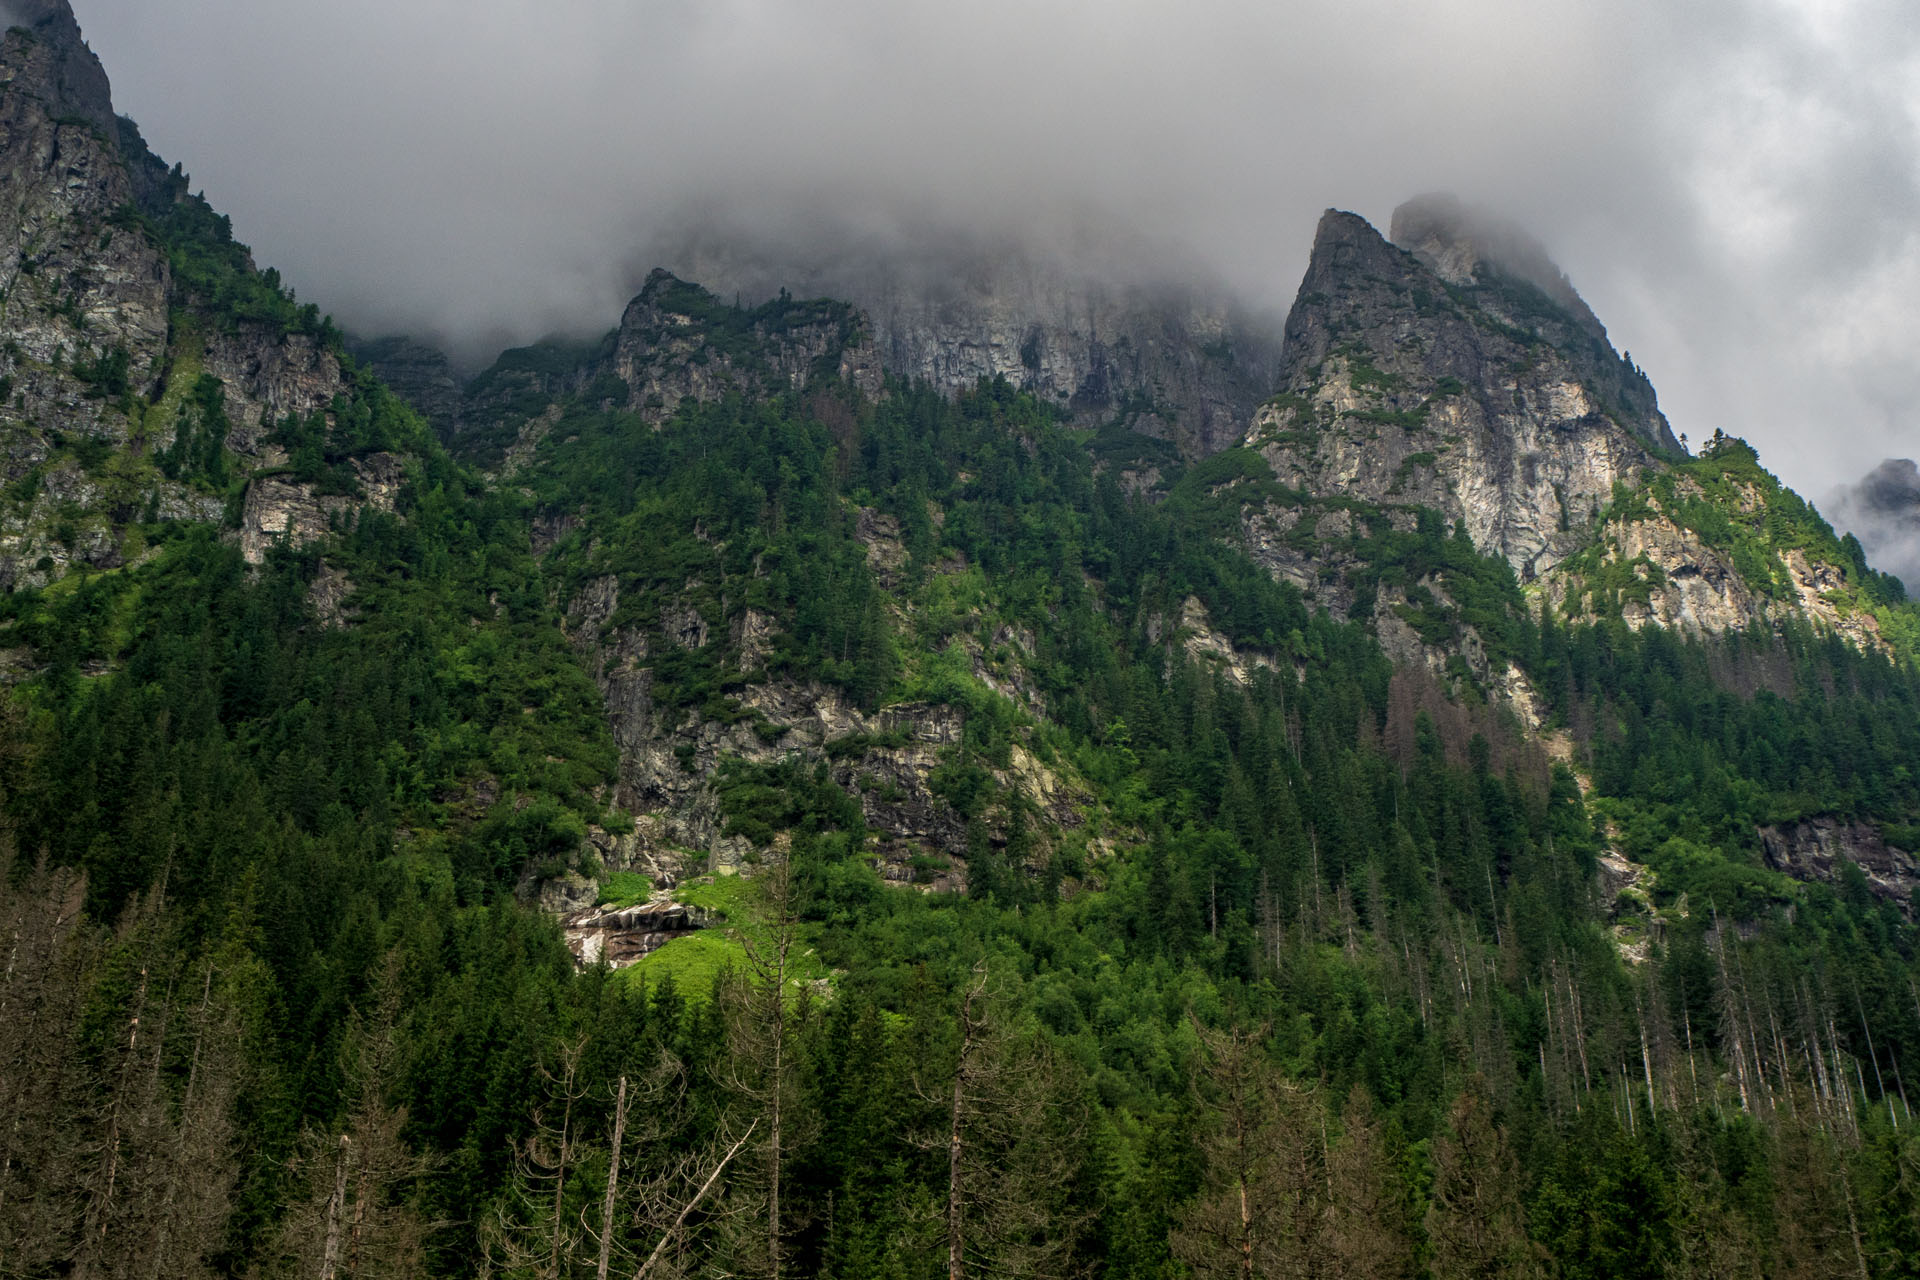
[1246,205,1678,580]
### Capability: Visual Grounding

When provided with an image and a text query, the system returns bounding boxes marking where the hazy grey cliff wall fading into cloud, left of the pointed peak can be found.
[656,246,1281,457]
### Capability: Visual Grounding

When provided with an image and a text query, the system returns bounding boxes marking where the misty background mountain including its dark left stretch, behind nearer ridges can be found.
[372,233,1281,457]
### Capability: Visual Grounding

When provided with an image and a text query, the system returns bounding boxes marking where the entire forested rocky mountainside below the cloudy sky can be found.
[0,2,1920,1278]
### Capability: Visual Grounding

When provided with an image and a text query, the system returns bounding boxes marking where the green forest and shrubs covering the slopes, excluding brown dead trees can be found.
[11,175,1920,1276]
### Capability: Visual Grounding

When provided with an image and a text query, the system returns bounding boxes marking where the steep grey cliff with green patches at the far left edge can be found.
[0,0,366,589]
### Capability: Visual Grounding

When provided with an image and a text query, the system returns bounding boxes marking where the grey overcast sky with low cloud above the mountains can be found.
[75,0,1920,497]
